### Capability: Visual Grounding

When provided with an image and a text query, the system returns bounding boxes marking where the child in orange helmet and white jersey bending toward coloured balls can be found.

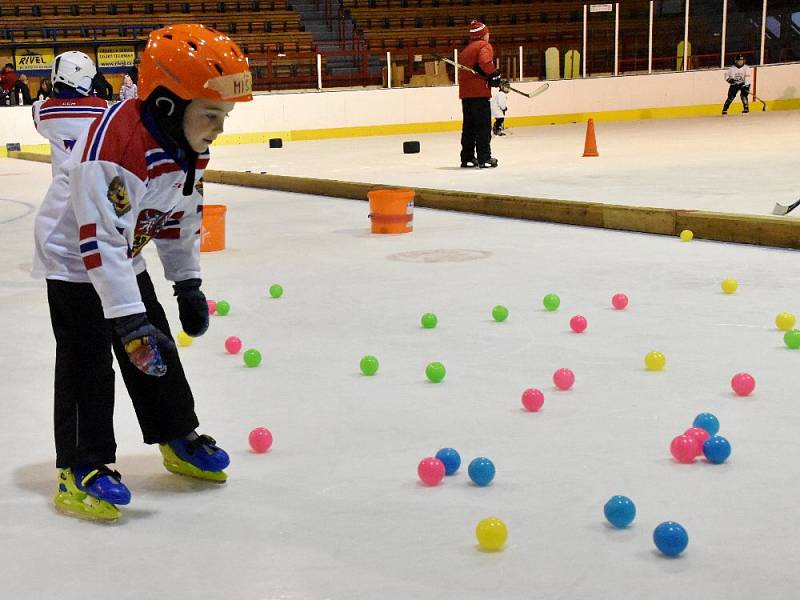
[35,25,252,520]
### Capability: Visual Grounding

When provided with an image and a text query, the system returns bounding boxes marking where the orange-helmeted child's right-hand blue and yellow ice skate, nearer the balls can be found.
[159,435,231,483]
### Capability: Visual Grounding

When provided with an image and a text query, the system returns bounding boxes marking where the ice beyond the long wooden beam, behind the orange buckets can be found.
[211,109,800,215]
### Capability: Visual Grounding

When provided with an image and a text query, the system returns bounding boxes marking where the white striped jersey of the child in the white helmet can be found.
[33,96,108,177]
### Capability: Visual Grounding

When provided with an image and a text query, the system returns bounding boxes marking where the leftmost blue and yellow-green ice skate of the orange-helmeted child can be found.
[53,465,131,521]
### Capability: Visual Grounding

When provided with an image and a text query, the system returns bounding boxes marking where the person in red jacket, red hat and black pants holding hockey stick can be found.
[458,21,501,169]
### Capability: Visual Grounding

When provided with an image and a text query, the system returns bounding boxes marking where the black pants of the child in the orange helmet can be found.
[47,272,198,468]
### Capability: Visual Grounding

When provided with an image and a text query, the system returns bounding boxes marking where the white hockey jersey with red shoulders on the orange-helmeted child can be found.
[34,100,209,319]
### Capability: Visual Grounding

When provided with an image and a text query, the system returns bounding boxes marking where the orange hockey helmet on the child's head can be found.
[139,24,253,102]
